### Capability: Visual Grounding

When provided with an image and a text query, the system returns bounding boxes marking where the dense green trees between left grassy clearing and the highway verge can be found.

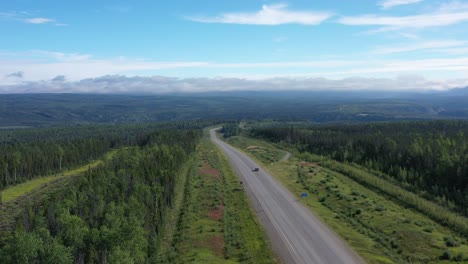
[0,130,201,263]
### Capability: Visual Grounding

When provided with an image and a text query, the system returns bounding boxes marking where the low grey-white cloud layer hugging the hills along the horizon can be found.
[0,75,468,94]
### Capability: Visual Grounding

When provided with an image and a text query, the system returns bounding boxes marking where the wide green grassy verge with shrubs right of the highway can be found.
[229,137,468,263]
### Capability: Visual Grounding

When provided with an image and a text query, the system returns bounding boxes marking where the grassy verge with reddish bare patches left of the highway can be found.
[168,134,276,263]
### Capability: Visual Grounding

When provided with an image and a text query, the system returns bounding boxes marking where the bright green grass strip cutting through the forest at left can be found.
[2,150,116,203]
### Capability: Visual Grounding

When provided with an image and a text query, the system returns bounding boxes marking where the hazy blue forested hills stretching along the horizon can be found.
[0,91,468,128]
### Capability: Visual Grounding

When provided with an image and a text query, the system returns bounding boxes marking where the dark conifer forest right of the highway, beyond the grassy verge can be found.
[250,121,468,215]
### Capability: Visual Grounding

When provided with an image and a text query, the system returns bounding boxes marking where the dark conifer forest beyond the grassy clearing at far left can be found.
[0,121,213,190]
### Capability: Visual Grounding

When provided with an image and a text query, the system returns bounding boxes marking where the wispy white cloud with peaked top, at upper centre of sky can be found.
[187,4,333,25]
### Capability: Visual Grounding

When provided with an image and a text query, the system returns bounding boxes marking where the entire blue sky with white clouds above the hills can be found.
[0,0,468,93]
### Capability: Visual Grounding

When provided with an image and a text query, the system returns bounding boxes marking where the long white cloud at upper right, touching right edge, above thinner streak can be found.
[338,11,468,31]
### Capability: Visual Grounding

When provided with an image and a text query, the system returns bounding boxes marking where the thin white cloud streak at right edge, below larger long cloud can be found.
[371,40,468,54]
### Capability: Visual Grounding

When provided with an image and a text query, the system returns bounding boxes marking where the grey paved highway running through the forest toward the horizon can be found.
[210,129,364,264]
